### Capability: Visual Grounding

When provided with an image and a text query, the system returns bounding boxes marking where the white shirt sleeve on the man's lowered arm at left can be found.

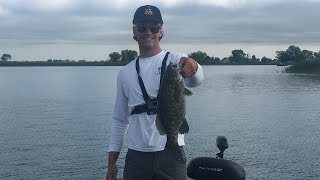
[109,71,129,152]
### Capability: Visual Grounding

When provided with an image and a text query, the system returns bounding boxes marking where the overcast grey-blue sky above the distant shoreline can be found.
[0,0,320,61]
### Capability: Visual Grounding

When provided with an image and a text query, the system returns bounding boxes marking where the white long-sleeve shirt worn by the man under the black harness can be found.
[109,51,203,152]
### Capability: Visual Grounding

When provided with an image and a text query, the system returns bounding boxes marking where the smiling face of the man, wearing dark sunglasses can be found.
[133,22,163,48]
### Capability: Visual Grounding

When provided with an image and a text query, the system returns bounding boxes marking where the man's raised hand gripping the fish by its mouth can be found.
[179,57,198,78]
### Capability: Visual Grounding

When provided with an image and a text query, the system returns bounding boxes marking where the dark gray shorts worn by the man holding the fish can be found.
[123,147,187,180]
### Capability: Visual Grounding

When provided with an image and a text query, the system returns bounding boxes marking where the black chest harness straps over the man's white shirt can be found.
[131,52,170,115]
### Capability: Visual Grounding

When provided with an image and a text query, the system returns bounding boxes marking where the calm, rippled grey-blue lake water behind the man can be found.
[0,66,320,180]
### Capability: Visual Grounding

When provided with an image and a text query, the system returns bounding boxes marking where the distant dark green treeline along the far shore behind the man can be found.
[0,45,320,66]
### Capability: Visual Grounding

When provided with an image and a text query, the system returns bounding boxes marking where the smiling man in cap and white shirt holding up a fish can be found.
[107,5,203,180]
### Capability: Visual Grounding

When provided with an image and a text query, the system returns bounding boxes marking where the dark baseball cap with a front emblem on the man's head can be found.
[132,5,163,24]
